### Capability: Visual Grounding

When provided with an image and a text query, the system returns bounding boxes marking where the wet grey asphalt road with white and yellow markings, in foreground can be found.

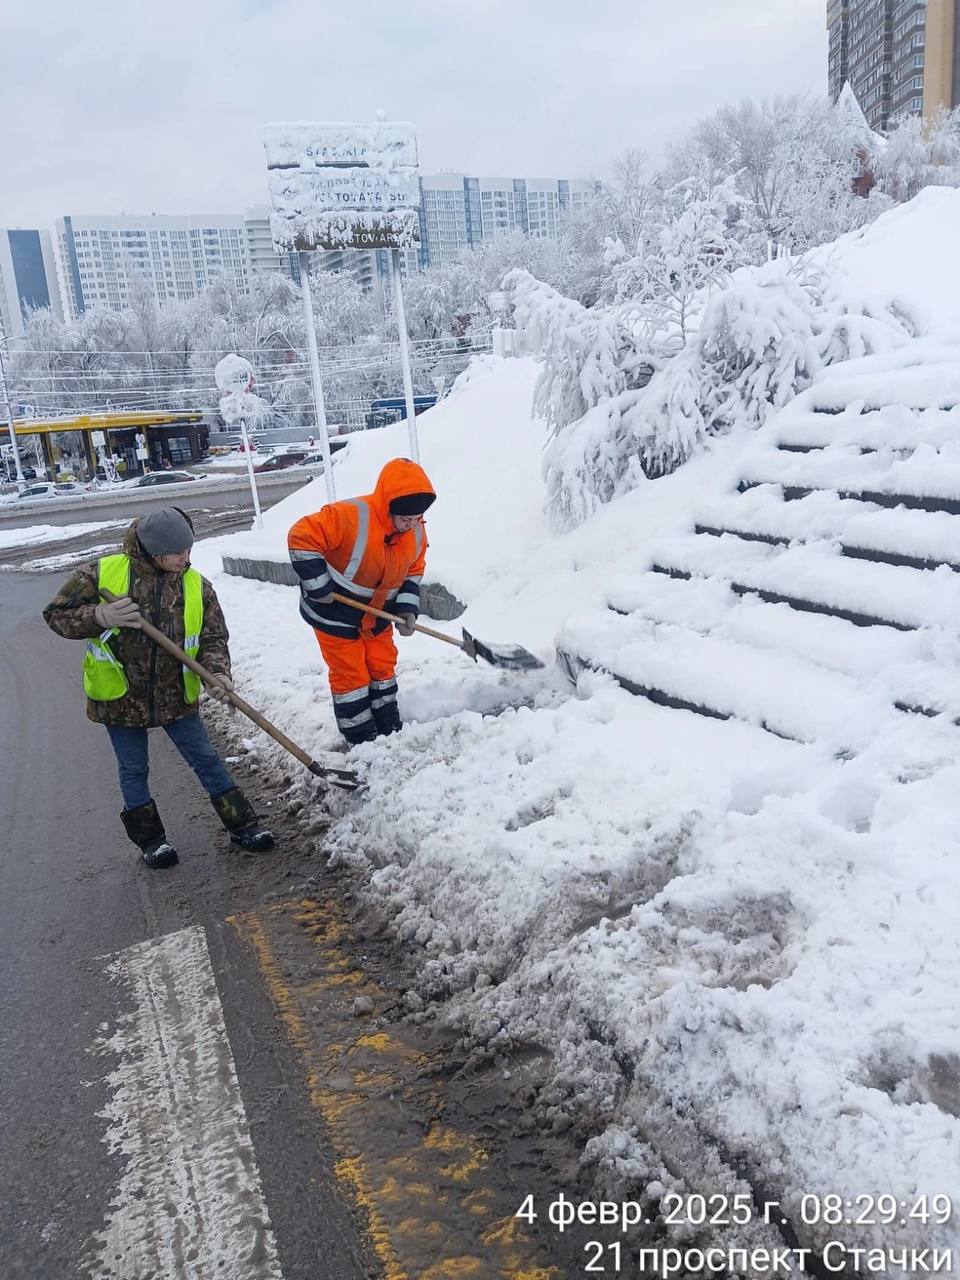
[0,529,624,1280]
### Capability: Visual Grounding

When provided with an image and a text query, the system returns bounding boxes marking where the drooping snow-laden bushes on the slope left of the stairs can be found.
[507,260,916,529]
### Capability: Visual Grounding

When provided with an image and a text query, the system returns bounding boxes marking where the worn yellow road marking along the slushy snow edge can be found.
[229,900,562,1280]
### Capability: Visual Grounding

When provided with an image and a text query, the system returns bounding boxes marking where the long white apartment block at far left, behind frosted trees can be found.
[55,214,251,319]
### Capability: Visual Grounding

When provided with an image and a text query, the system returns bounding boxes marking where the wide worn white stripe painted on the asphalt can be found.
[87,927,283,1280]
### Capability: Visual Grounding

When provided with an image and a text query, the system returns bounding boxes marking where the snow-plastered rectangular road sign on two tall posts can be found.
[264,120,420,471]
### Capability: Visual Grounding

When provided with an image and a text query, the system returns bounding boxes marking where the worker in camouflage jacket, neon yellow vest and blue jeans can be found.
[44,507,274,868]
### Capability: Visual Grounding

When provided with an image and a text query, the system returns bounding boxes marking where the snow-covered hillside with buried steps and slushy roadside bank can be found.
[196,191,960,1275]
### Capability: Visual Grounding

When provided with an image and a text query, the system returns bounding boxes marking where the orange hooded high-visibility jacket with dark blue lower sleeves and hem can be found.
[287,458,434,637]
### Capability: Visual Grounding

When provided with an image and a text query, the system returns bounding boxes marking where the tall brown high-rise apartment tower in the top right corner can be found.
[827,0,960,131]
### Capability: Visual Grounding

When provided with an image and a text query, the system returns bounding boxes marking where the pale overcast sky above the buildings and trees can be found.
[0,0,827,227]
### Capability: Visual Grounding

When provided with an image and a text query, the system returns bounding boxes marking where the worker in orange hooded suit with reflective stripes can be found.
[287,458,436,745]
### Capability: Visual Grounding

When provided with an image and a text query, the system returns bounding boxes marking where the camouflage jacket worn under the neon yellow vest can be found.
[44,521,230,728]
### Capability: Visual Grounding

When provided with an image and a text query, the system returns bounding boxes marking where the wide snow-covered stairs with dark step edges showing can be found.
[559,352,960,755]
